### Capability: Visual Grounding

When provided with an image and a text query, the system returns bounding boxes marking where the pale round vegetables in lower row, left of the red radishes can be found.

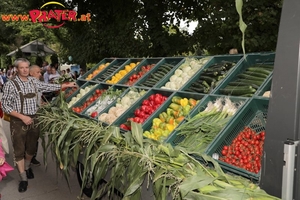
[98,88,146,124]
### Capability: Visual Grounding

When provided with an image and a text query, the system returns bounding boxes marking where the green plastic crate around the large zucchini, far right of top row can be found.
[212,53,275,95]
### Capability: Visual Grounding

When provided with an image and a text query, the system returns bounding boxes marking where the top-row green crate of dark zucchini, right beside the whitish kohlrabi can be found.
[180,55,243,94]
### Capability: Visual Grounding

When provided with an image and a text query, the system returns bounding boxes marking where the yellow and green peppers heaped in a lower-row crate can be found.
[143,96,199,141]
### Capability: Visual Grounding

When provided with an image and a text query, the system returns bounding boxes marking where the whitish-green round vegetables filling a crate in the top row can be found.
[161,57,210,90]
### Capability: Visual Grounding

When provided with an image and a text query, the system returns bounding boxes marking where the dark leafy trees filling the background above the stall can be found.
[0,0,282,63]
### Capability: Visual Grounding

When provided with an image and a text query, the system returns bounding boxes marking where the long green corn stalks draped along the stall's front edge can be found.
[38,93,279,200]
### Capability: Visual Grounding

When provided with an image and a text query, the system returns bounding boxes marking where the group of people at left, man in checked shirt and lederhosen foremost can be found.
[0,58,76,192]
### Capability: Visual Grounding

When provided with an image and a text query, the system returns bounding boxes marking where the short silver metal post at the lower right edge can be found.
[281,140,299,200]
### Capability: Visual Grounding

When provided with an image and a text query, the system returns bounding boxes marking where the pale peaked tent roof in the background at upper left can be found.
[7,40,56,56]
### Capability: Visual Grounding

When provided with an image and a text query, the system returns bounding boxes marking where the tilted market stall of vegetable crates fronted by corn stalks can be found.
[40,53,277,199]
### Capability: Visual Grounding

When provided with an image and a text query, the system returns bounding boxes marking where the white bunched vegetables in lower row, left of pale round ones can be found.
[83,87,124,121]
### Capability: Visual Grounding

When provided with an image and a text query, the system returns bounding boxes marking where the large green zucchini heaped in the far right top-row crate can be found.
[220,64,273,97]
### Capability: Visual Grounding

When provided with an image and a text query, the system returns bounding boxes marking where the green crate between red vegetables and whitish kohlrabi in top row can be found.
[134,57,184,87]
